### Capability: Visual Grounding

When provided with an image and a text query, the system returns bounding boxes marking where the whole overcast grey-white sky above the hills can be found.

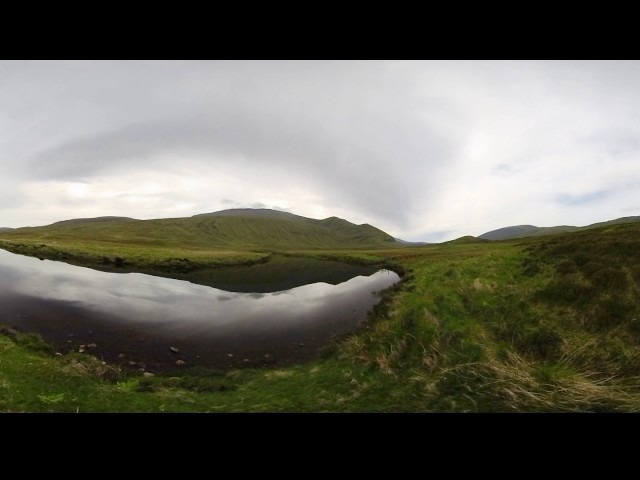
[0,61,640,242]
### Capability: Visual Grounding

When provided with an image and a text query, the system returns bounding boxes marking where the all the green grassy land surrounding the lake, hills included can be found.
[0,217,640,412]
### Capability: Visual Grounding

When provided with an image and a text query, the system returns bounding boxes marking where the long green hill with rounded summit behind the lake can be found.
[3,209,397,251]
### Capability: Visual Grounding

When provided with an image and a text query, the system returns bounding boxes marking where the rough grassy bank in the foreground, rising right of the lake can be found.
[0,224,640,412]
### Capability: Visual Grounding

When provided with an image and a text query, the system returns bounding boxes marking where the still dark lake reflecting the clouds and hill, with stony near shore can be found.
[0,250,399,372]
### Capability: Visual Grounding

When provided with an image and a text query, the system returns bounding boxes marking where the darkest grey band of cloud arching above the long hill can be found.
[29,77,455,229]
